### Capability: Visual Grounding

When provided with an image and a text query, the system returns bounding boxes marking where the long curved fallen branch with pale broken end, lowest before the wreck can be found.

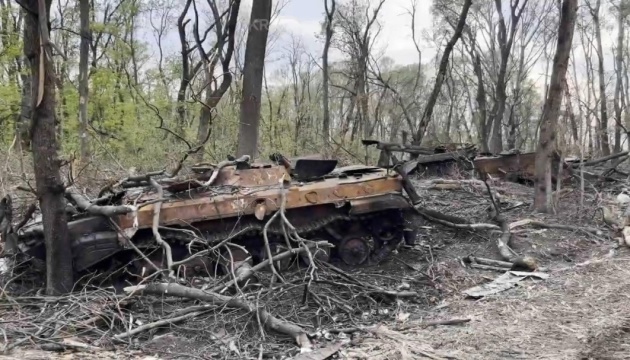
[124,283,311,349]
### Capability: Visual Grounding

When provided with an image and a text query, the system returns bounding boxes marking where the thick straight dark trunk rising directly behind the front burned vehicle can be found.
[237,0,272,159]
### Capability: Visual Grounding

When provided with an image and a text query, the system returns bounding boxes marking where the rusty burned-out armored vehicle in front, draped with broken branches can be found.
[12,154,418,282]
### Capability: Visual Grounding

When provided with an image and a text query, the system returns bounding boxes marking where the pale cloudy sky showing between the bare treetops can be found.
[131,0,616,94]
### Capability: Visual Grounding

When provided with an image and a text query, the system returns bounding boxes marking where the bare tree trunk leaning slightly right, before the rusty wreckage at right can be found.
[534,0,577,212]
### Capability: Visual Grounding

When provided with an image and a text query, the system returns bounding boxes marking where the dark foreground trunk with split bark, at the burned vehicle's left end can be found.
[24,0,74,295]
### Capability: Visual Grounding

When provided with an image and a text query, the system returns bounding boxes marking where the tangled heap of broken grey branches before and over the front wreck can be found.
[0,167,430,358]
